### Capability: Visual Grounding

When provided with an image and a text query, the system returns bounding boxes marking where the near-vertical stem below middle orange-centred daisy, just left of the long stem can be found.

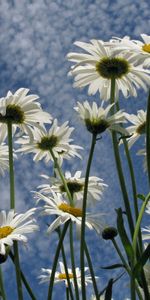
[70,223,79,300]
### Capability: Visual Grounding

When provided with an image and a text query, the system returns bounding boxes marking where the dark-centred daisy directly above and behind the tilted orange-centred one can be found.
[38,171,107,204]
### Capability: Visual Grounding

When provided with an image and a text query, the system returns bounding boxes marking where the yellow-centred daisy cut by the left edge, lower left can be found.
[0,208,38,255]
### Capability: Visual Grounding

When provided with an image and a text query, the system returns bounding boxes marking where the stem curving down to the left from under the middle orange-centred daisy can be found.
[47,220,70,300]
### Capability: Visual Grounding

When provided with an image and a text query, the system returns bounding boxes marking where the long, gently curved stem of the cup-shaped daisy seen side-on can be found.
[80,134,96,300]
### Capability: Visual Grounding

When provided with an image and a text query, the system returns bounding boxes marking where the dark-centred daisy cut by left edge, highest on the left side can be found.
[0,88,52,138]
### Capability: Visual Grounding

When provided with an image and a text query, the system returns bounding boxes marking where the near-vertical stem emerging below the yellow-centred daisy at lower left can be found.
[14,241,23,300]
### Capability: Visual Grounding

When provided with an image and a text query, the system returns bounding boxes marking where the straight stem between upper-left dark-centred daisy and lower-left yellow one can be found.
[7,122,15,209]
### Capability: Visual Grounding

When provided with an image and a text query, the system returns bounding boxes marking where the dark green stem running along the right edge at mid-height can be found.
[146,91,150,186]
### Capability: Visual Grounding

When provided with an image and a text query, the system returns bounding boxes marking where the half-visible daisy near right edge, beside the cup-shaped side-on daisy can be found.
[125,109,146,148]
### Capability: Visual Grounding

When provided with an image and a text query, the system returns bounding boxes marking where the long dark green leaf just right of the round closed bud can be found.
[116,208,134,262]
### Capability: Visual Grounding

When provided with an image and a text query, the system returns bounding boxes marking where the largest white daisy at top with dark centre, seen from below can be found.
[67,40,150,100]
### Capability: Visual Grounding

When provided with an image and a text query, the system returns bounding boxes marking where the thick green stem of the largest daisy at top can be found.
[111,78,134,236]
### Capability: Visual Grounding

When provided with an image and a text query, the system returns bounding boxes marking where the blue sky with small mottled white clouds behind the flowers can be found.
[0,0,150,300]
